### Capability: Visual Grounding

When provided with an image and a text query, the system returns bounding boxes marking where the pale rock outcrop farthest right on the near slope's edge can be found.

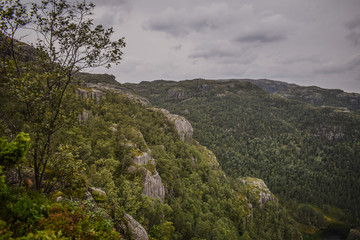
[240,177,276,207]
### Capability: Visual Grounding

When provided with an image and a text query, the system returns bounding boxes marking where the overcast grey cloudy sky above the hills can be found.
[23,0,360,93]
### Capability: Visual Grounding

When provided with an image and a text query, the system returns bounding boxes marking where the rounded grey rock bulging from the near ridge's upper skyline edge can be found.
[151,108,194,141]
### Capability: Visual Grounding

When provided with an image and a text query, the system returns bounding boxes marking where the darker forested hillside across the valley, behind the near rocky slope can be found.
[126,79,360,238]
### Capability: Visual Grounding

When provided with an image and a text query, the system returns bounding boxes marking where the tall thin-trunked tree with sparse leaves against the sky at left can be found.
[0,0,125,190]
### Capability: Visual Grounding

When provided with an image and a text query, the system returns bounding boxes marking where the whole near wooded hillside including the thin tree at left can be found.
[0,0,310,240]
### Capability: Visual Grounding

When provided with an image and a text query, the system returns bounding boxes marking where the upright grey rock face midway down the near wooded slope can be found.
[143,170,165,202]
